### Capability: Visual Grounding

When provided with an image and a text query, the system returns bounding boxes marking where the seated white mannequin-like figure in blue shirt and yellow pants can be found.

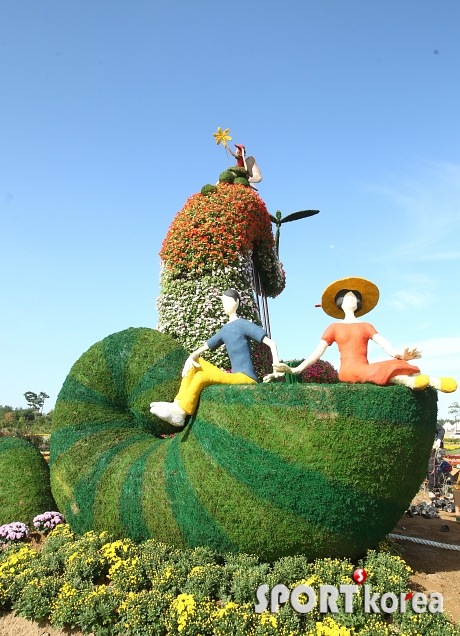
[150,289,284,426]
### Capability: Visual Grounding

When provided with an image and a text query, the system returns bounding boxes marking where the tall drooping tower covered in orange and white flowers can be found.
[157,179,285,369]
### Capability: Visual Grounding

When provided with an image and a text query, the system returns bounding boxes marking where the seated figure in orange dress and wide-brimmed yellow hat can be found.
[270,277,457,393]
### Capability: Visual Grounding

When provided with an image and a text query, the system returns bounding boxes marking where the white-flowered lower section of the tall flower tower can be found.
[157,254,261,370]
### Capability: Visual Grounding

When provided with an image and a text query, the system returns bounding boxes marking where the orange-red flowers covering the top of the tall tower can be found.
[160,183,274,274]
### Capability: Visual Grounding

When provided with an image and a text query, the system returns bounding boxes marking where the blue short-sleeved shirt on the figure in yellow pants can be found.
[206,318,267,382]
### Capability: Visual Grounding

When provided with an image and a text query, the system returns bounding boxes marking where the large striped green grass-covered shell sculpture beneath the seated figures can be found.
[51,329,436,560]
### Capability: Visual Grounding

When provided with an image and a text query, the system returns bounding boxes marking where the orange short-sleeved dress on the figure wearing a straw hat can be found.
[322,322,420,386]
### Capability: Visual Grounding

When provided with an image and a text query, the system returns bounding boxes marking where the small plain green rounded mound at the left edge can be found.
[0,437,56,526]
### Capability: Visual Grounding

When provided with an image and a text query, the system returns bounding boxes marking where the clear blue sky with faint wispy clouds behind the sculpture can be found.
[0,0,460,416]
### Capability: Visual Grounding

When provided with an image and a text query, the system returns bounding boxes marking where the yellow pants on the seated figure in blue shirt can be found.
[175,358,256,415]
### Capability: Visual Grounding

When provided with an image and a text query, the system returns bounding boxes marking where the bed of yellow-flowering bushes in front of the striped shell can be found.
[0,525,460,636]
